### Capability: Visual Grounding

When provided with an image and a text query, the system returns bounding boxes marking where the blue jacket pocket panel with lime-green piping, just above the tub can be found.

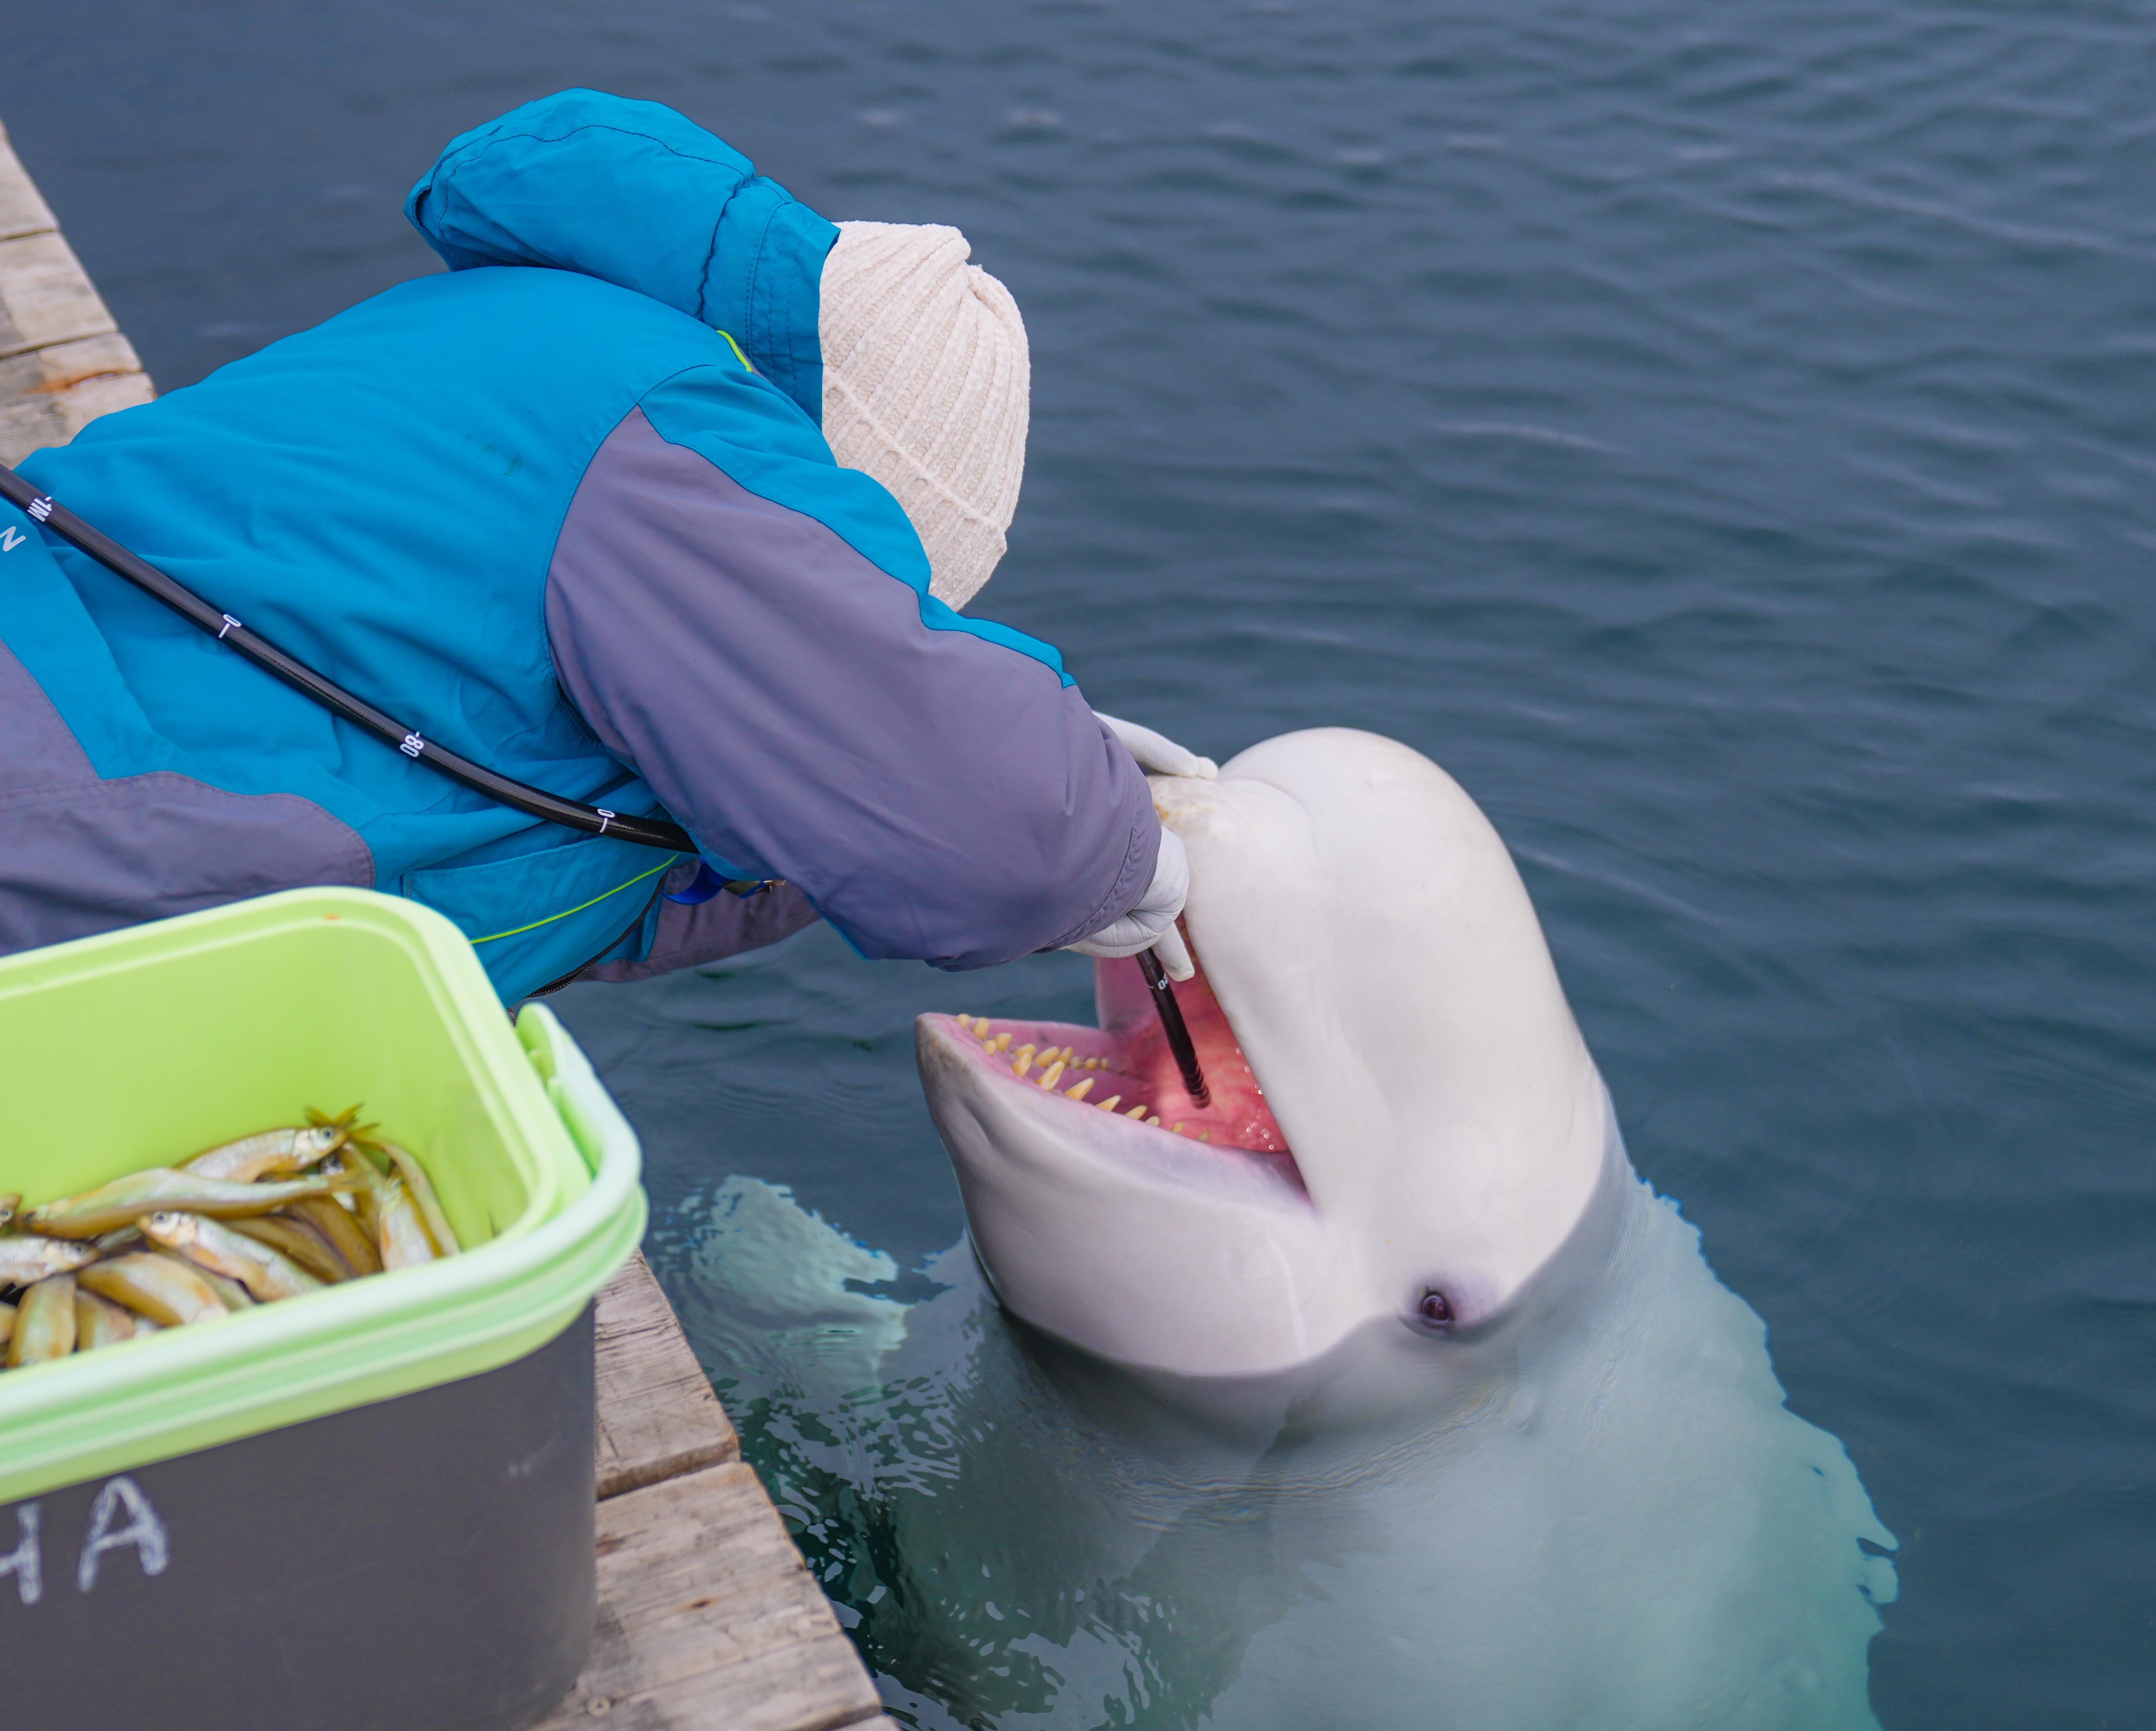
[403,837,681,1005]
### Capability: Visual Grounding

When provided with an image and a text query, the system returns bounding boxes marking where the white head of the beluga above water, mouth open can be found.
[916,729,1624,1377]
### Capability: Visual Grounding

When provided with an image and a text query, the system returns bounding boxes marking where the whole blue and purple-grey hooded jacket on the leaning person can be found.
[0,91,1160,1000]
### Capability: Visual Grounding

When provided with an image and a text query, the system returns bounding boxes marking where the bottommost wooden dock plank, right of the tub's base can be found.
[539,1462,888,1731]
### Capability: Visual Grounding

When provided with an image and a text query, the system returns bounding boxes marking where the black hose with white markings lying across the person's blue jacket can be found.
[0,463,761,894]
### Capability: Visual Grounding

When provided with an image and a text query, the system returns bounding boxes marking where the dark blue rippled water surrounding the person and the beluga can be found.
[0,0,2156,1729]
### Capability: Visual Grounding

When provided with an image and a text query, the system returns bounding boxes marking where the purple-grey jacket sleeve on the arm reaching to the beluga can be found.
[547,409,1160,972]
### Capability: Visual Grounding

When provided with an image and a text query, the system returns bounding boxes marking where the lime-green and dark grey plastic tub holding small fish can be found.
[0,890,645,1731]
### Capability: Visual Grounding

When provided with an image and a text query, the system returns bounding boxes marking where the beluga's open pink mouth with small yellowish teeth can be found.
[927,961,1302,1190]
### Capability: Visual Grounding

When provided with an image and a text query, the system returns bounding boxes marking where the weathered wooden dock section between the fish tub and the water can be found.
[573,1257,897,1731]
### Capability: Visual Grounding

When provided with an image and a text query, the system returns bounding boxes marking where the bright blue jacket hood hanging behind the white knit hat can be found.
[405,91,839,427]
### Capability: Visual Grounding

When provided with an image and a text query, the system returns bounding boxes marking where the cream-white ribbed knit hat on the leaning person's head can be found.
[817,222,1033,608]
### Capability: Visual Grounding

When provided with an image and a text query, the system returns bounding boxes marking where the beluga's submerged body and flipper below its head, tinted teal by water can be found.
[683,1153,1895,1731]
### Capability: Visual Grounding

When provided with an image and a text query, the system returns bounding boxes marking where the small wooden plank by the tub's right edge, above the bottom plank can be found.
[597,1253,742,1500]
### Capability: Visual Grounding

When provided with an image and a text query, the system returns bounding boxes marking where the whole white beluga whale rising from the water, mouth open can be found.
[884,729,1897,1731]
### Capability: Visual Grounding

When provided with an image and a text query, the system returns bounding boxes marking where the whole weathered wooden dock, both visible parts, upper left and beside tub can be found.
[0,108,897,1731]
